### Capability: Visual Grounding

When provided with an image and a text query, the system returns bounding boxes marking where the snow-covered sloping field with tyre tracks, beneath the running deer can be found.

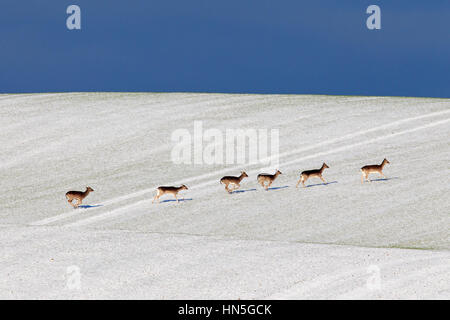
[0,93,450,299]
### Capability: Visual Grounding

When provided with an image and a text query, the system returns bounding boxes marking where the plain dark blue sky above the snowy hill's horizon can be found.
[0,0,450,97]
